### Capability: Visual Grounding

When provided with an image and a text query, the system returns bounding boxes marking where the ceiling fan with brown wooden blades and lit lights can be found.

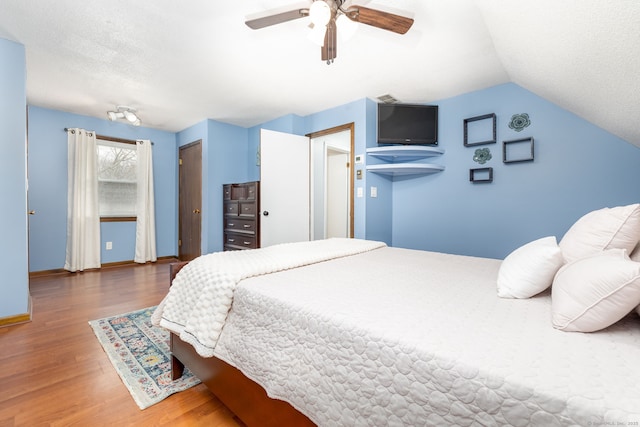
[245,0,413,64]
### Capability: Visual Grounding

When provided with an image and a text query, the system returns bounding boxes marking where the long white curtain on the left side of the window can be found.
[64,128,100,271]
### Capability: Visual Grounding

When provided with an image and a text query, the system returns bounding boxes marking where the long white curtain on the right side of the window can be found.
[133,140,158,264]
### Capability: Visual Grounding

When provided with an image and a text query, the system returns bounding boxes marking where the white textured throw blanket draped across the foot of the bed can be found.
[151,238,385,357]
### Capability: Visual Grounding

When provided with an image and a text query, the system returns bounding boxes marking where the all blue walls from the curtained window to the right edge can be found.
[22,84,640,271]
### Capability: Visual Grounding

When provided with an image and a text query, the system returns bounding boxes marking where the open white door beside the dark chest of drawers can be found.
[260,129,309,247]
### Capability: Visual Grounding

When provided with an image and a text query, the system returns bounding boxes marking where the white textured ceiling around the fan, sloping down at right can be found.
[0,0,640,146]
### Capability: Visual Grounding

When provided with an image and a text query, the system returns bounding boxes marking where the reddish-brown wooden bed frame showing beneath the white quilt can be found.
[169,262,315,427]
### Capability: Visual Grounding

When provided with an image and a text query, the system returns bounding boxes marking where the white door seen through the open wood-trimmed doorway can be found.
[325,148,349,238]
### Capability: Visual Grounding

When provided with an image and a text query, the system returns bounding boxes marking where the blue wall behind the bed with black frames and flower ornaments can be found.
[388,84,640,258]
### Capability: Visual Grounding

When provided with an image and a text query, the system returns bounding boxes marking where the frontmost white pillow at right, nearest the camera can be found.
[551,249,640,332]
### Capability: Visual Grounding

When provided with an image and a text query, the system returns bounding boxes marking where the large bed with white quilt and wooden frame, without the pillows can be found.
[154,234,640,426]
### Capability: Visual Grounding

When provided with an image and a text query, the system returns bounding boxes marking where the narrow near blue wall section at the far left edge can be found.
[0,39,29,318]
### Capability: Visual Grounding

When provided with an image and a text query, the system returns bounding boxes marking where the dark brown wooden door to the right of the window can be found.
[178,140,202,261]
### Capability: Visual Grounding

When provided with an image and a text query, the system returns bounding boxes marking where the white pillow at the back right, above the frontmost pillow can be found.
[560,203,640,262]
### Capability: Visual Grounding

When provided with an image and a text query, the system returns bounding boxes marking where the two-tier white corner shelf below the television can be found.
[367,145,444,176]
